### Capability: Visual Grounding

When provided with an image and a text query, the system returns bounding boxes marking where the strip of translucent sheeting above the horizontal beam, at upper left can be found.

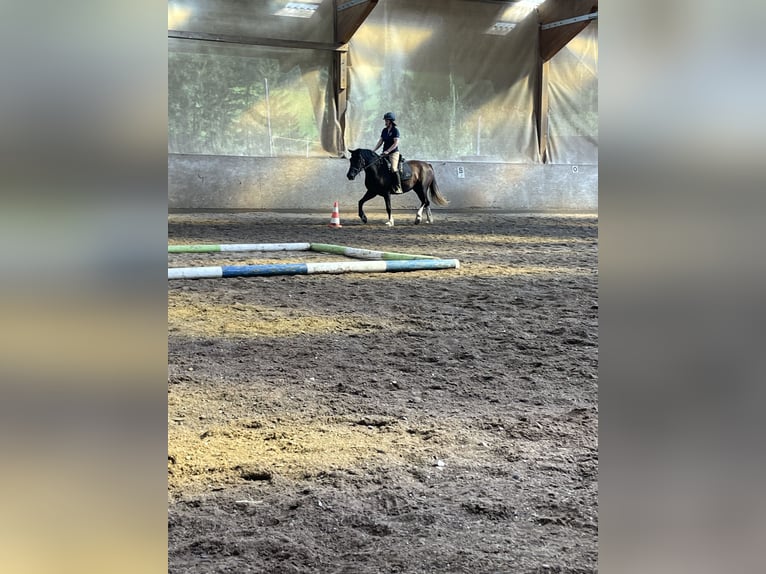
[168,0,334,42]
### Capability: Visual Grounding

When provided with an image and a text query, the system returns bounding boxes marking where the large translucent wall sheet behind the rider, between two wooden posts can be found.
[346,0,539,163]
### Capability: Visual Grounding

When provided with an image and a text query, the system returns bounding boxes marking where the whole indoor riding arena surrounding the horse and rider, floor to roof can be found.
[168,0,599,574]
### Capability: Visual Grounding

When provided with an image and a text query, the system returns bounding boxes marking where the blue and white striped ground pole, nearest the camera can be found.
[168,259,460,279]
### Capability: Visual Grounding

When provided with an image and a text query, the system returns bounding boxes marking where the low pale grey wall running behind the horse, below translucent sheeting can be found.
[168,154,598,212]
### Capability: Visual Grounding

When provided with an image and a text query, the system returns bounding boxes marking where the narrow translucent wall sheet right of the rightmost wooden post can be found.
[548,20,598,164]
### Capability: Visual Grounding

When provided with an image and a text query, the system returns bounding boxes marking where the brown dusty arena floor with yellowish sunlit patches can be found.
[168,209,598,574]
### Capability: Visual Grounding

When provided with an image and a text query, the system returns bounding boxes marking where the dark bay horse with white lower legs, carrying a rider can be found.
[346,149,449,225]
